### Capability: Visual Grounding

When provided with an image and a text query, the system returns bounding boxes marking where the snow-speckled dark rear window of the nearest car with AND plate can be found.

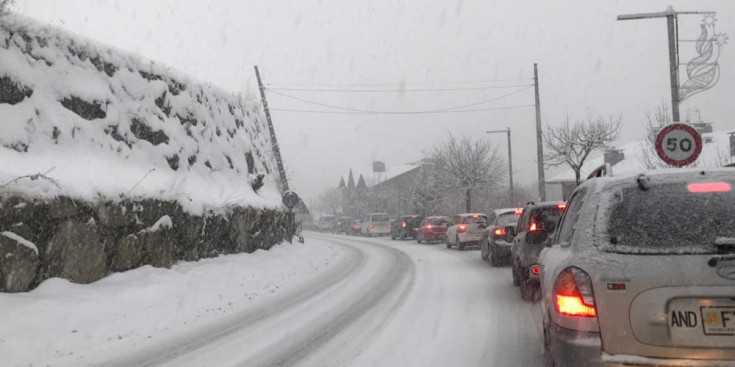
[598,182,735,254]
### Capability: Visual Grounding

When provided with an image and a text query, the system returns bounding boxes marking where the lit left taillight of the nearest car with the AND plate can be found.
[554,267,597,317]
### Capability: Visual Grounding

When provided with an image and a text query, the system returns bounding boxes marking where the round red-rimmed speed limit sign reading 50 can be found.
[656,123,702,167]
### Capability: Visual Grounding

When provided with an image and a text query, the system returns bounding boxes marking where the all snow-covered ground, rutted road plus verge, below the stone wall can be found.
[0,233,542,367]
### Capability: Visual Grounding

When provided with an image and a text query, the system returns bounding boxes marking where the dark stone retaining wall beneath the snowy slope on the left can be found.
[0,194,292,292]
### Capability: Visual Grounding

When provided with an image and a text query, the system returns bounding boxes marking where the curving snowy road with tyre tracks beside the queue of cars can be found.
[116,233,543,366]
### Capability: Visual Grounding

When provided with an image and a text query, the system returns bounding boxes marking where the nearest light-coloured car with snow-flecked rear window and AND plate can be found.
[527,168,735,366]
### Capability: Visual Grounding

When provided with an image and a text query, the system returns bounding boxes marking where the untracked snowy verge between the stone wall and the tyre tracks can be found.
[0,241,345,366]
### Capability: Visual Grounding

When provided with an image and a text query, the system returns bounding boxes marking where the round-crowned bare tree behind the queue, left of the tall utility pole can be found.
[429,135,507,212]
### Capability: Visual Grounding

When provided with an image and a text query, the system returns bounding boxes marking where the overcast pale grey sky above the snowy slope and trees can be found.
[14,0,735,202]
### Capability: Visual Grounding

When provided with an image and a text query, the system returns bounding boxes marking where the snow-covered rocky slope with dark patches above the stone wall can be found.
[0,15,280,214]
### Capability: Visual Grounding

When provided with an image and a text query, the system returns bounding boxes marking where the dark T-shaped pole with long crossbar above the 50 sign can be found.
[618,7,715,122]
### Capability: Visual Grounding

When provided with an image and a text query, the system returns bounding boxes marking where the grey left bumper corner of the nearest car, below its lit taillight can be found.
[549,323,604,367]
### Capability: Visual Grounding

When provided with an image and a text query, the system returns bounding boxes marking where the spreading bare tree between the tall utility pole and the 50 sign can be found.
[543,116,622,185]
